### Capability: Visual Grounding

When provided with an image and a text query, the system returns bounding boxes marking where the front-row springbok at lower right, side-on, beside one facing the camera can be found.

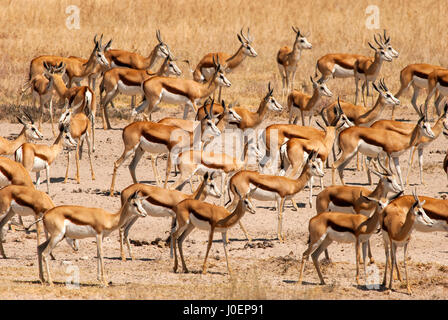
[297,193,401,285]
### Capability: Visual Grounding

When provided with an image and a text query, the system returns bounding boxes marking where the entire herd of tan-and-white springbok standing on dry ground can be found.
[0,27,448,294]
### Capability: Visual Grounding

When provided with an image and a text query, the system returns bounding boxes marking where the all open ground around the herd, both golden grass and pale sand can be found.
[0,0,448,299]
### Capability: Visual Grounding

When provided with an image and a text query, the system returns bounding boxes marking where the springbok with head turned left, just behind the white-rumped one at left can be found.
[59,109,95,184]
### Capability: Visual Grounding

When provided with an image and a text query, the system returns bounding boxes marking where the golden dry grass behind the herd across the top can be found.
[0,0,448,112]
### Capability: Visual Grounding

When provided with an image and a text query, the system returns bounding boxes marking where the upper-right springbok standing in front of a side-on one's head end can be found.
[353,35,393,106]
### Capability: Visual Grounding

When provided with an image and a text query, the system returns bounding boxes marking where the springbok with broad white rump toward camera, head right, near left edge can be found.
[15,125,76,194]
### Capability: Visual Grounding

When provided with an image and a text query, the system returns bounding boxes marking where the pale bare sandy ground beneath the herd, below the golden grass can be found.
[0,106,448,299]
